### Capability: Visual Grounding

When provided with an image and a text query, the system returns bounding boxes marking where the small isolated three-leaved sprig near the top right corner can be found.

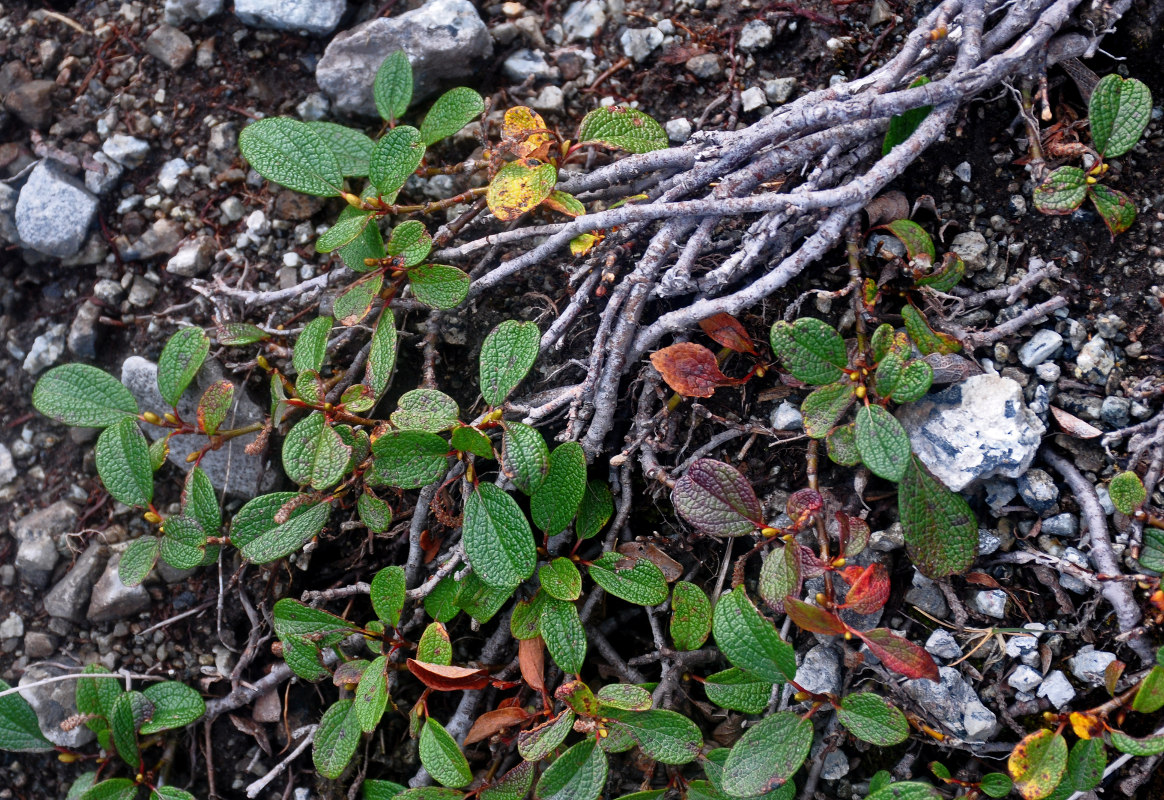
[1035,75,1152,236]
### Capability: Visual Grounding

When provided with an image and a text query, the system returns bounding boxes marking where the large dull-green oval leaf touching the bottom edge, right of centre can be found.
[723,711,812,798]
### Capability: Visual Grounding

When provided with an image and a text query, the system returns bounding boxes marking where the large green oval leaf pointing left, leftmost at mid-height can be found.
[33,363,137,427]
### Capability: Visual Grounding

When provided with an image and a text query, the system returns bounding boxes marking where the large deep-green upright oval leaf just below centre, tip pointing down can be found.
[461,483,535,589]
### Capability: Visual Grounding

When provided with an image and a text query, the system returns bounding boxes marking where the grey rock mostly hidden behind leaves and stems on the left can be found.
[121,356,265,498]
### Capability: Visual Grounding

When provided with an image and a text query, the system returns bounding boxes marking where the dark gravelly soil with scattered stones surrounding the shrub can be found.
[0,0,1164,800]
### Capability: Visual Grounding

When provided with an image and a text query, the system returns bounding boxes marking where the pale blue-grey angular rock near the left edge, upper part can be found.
[15,160,97,259]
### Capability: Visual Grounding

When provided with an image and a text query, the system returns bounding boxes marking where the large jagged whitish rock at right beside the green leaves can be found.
[897,375,1046,491]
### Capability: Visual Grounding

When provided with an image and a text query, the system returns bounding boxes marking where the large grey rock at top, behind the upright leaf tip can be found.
[315,0,494,116]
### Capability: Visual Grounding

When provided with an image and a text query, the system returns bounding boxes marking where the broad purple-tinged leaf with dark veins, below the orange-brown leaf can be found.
[670,459,764,536]
